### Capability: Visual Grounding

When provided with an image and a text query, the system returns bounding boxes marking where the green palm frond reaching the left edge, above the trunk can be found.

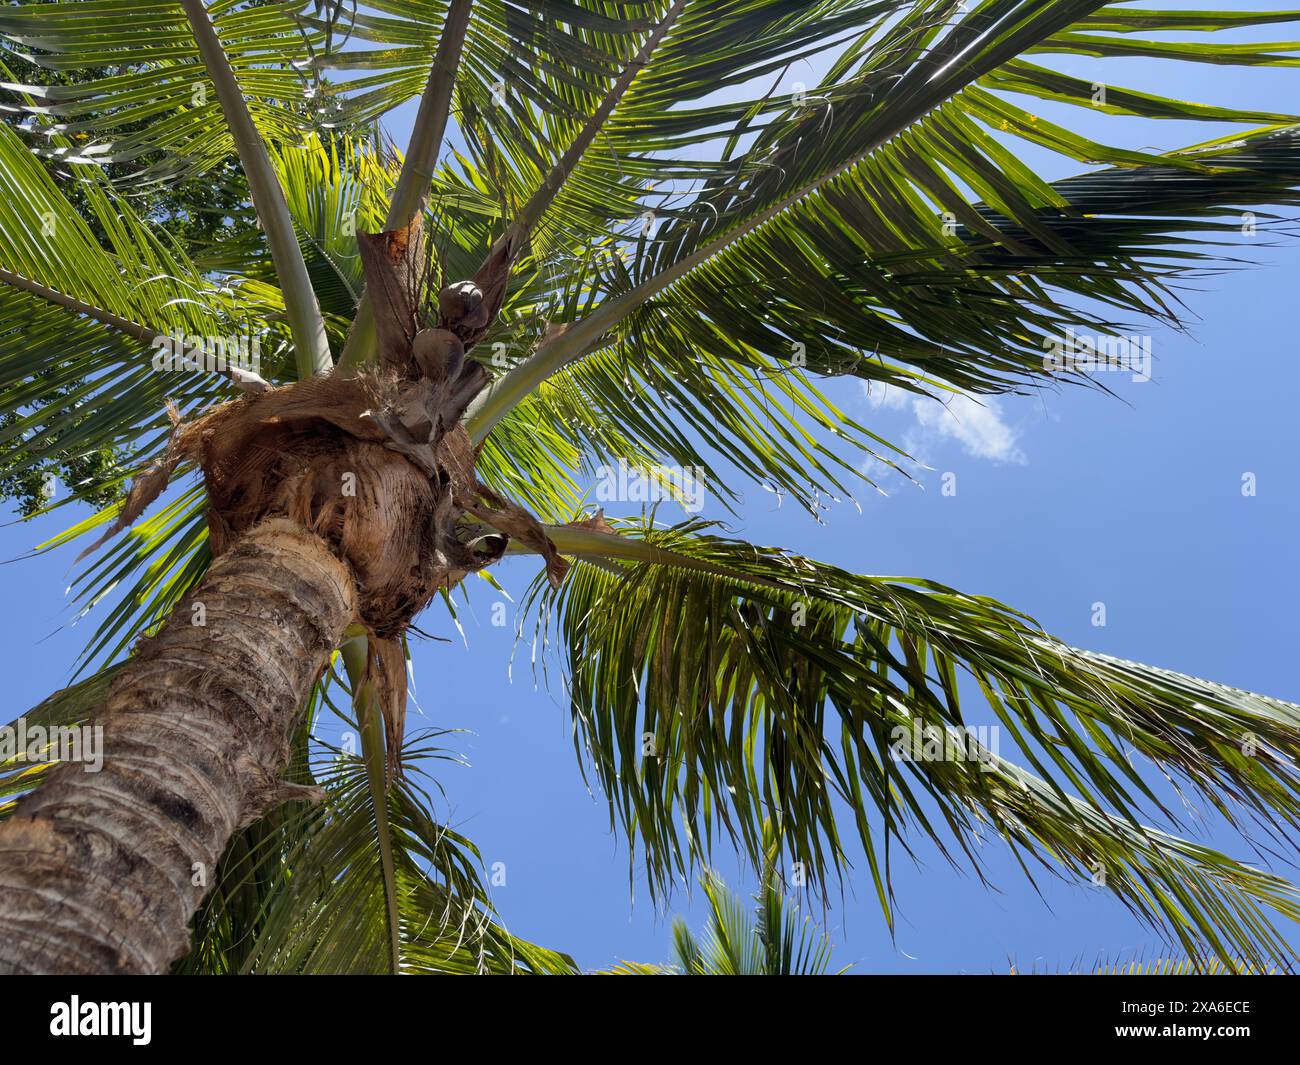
[0,116,286,496]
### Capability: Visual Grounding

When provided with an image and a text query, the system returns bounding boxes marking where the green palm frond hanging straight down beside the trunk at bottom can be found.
[177,681,576,974]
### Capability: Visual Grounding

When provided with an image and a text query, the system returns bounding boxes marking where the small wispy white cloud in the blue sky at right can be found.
[862,381,1026,466]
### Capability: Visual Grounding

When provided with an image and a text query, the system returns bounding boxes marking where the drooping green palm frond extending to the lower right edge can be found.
[525,521,1300,960]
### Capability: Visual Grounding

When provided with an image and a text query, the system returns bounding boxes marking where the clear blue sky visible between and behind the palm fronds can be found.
[0,4,1300,973]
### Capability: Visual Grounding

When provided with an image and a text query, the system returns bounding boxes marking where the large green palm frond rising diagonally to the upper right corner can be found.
[472,3,1300,434]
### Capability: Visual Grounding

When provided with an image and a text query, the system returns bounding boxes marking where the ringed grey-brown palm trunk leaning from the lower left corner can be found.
[0,519,356,974]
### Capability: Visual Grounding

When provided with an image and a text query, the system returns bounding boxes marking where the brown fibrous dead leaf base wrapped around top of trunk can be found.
[90,226,567,772]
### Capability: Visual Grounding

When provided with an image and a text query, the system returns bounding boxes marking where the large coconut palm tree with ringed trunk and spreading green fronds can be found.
[0,0,1300,973]
